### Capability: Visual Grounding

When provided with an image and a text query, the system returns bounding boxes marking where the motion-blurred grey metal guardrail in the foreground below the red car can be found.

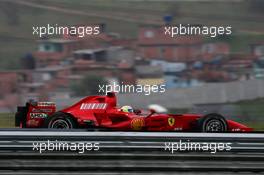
[0,129,264,175]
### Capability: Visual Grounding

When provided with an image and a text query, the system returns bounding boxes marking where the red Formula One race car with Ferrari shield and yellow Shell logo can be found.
[16,93,252,132]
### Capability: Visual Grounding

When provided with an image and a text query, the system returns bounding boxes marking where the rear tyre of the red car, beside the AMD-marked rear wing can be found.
[43,112,77,129]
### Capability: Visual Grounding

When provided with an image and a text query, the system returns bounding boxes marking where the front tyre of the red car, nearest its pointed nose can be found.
[198,113,228,133]
